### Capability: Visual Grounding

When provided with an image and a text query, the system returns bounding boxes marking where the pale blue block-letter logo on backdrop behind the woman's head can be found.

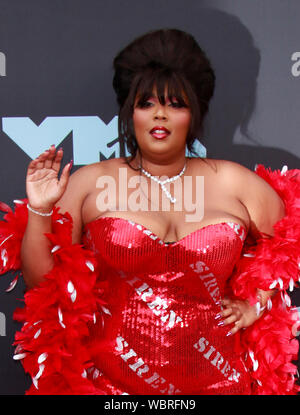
[2,116,206,165]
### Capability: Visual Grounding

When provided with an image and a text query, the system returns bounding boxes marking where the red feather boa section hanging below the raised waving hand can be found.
[0,200,107,395]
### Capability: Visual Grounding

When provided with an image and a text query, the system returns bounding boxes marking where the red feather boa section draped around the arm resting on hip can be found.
[231,165,300,395]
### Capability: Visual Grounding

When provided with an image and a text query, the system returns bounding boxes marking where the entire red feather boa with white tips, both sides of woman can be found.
[0,165,300,395]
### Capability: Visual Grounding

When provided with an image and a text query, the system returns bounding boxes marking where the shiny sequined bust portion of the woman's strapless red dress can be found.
[84,217,246,279]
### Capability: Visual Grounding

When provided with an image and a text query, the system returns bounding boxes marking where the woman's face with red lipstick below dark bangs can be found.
[133,92,191,161]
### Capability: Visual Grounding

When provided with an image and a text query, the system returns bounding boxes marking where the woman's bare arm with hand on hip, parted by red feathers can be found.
[216,161,285,334]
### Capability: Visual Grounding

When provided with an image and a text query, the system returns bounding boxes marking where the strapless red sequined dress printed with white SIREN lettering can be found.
[84,217,251,395]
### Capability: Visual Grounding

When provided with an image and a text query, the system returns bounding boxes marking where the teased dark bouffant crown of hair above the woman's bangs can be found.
[113,29,215,106]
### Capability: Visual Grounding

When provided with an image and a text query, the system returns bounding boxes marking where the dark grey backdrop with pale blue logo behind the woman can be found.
[0,0,300,395]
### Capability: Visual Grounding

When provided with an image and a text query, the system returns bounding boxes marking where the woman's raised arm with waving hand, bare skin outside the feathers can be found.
[21,146,85,288]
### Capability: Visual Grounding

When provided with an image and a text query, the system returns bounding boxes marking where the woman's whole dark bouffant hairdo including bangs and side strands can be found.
[113,29,215,166]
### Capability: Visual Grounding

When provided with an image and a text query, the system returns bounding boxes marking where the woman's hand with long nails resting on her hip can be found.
[215,297,261,336]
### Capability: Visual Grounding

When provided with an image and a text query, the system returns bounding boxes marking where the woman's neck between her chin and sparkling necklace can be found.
[134,152,187,177]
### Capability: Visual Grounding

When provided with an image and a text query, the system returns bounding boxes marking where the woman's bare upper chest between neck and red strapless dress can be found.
[82,160,249,242]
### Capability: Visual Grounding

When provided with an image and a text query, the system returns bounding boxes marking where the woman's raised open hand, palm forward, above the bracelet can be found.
[26,145,72,211]
